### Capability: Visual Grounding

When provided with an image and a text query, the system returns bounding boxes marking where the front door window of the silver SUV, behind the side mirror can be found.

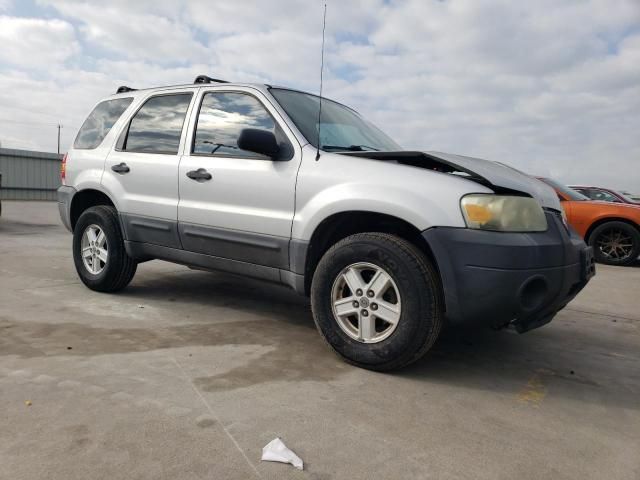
[192,92,293,159]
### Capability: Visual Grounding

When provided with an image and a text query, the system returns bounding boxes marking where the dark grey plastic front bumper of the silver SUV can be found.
[422,211,595,333]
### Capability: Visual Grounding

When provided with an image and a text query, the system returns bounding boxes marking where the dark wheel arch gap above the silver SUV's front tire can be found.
[304,210,440,295]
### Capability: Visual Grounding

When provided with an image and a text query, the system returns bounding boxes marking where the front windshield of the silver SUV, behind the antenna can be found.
[270,88,402,152]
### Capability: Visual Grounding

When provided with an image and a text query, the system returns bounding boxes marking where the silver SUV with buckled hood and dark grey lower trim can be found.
[59,76,594,370]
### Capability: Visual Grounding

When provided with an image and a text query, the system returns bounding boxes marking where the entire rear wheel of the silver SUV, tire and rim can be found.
[73,205,137,292]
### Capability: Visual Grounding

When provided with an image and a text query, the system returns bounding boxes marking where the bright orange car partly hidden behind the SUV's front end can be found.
[540,178,640,265]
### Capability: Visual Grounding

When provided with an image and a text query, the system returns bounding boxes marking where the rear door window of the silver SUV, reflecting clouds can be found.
[122,93,193,155]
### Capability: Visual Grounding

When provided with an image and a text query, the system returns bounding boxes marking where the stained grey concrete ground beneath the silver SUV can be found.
[0,202,640,480]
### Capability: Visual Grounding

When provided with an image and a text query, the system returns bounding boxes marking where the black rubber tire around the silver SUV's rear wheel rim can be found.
[73,205,138,292]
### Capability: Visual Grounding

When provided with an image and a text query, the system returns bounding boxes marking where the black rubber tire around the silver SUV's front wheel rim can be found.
[311,233,444,371]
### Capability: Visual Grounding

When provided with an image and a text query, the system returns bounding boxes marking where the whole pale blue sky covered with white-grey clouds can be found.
[0,0,640,192]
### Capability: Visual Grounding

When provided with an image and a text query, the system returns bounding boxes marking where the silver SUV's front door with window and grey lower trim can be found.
[178,87,301,268]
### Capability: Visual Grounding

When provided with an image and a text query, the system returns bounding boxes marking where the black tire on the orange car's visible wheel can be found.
[589,222,640,266]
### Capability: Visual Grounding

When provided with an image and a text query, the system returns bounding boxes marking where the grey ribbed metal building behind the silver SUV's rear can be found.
[0,148,62,200]
